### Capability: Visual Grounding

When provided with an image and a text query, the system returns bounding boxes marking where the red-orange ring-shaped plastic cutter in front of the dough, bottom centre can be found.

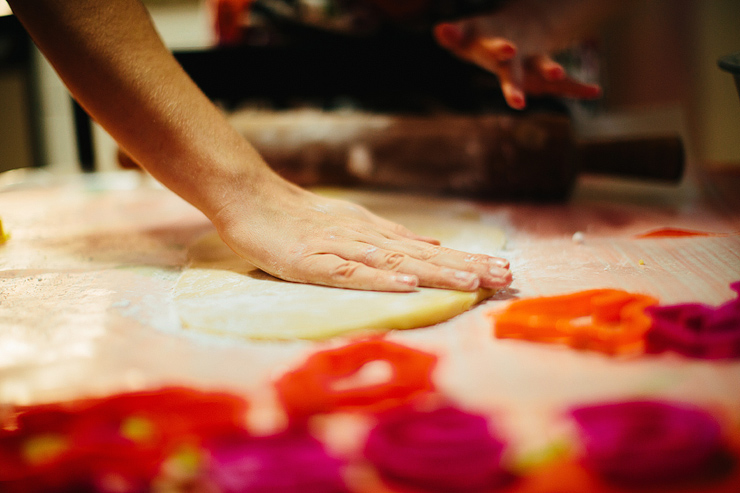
[275,339,437,418]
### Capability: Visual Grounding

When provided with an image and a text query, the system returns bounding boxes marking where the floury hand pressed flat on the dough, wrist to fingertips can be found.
[213,172,512,291]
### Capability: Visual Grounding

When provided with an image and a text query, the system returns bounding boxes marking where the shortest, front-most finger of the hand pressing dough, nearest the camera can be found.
[290,254,419,292]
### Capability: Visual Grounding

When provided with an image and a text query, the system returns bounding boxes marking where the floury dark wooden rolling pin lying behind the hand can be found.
[231,109,685,200]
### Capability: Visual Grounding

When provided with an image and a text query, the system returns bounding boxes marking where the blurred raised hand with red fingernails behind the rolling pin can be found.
[434,0,611,109]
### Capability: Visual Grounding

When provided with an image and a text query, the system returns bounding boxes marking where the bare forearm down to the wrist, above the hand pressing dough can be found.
[9,0,269,217]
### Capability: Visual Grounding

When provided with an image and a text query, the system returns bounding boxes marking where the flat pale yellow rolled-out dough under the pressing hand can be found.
[175,191,505,340]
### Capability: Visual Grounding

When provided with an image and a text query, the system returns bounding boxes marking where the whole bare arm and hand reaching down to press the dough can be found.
[9,0,512,291]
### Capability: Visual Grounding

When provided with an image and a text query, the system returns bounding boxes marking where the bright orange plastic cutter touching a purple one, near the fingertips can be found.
[489,289,658,354]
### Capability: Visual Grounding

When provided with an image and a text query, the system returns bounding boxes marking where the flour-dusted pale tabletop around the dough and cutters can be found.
[0,168,740,472]
